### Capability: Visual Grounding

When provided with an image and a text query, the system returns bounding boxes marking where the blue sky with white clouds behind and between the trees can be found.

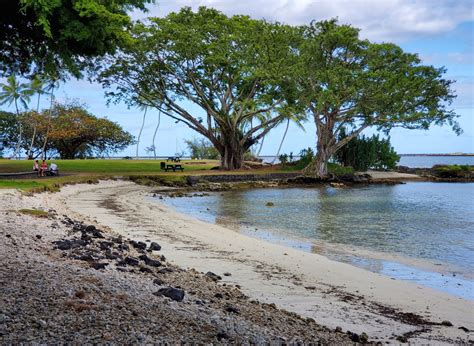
[1,0,474,156]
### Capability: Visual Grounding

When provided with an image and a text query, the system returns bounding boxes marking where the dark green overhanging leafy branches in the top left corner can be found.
[0,0,153,76]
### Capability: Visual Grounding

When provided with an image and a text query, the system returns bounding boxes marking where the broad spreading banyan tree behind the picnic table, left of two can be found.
[99,8,297,170]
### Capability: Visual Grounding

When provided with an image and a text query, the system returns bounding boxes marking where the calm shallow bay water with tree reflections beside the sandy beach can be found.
[160,182,474,300]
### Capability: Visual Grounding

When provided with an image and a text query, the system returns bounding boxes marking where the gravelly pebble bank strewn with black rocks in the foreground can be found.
[0,189,356,344]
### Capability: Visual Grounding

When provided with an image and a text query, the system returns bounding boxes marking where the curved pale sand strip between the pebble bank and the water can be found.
[42,181,474,343]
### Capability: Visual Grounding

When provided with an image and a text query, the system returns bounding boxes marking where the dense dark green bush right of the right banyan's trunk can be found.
[334,129,400,171]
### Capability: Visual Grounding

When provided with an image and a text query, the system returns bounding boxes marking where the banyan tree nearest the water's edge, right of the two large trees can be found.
[297,20,461,177]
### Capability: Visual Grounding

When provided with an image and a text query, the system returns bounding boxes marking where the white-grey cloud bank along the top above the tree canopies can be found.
[134,0,474,41]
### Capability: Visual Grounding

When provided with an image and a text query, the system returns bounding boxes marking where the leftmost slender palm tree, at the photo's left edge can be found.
[0,75,31,158]
